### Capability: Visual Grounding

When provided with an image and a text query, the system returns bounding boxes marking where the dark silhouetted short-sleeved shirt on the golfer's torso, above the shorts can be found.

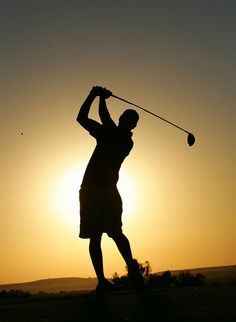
[81,123,133,187]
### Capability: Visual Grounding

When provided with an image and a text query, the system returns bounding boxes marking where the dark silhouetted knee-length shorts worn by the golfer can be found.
[79,186,122,238]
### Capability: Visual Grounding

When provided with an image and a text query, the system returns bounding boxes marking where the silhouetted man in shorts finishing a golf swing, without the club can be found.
[77,86,143,291]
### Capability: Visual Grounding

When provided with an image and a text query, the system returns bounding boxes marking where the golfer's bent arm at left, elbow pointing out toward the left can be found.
[76,87,99,131]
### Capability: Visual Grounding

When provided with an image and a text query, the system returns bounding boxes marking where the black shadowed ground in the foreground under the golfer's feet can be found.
[0,286,236,322]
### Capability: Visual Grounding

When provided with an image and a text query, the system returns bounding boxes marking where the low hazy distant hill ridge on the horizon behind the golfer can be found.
[0,265,236,293]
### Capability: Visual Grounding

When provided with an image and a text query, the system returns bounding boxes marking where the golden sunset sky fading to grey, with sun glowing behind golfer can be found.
[0,0,236,283]
